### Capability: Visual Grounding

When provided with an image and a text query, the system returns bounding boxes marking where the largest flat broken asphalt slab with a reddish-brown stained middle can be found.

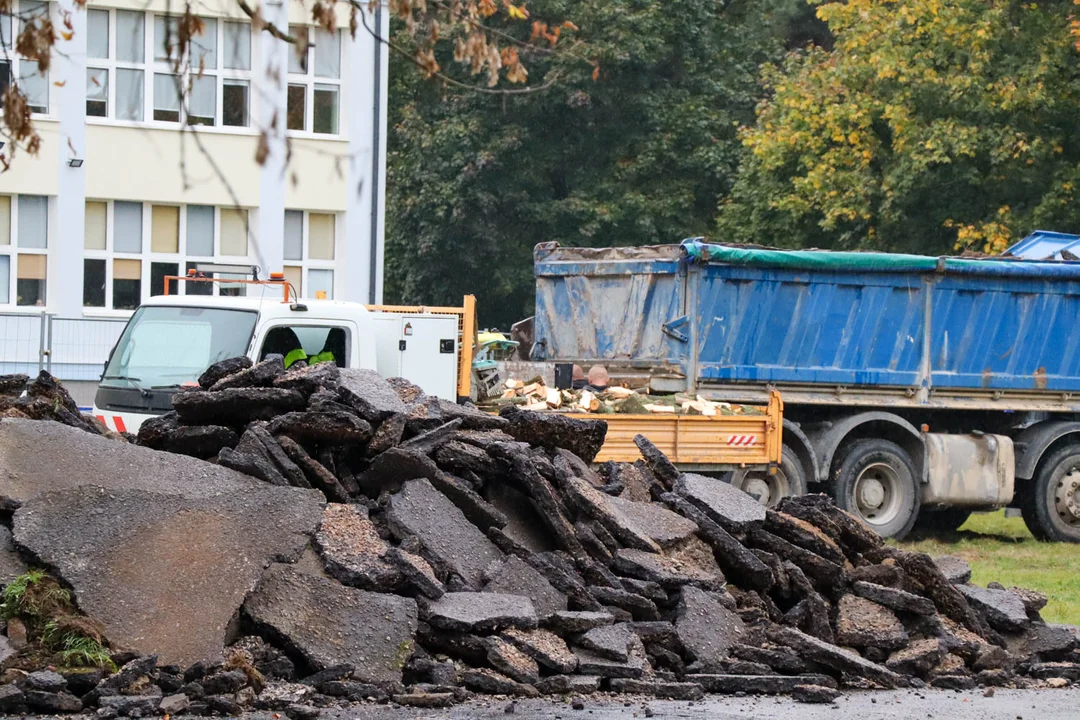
[13,481,323,665]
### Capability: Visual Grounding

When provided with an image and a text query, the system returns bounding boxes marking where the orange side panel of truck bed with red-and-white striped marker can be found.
[570,392,784,470]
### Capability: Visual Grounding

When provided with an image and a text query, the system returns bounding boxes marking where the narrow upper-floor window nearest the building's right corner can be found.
[286,26,341,135]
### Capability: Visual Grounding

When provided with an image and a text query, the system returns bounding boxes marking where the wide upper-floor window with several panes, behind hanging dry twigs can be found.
[86,10,252,127]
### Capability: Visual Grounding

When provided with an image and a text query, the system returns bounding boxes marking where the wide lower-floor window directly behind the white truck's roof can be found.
[83,201,249,310]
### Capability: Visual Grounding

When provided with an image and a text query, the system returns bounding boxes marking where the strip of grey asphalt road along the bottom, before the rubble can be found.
[295,689,1080,720]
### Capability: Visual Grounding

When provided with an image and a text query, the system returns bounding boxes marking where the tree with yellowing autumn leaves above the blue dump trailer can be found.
[718,0,1080,254]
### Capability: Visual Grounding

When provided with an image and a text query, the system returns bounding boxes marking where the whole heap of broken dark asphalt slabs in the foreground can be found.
[0,357,1080,718]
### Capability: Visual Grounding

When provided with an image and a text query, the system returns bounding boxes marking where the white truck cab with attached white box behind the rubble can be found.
[93,290,471,433]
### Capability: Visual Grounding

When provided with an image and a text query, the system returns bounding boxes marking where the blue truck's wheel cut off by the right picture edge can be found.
[1021,445,1080,543]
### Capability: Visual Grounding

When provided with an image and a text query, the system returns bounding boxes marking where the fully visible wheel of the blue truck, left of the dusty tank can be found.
[833,438,921,539]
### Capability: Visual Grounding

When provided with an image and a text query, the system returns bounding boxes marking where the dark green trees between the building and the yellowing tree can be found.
[386,0,803,328]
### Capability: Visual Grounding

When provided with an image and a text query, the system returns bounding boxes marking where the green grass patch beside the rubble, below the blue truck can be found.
[899,511,1080,625]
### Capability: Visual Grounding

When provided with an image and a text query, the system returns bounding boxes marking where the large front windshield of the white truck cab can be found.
[102,305,258,390]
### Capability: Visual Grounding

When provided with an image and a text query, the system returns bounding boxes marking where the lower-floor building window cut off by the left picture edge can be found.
[0,195,49,308]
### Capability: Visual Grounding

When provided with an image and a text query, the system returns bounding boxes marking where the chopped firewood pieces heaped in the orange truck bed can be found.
[489,377,764,417]
